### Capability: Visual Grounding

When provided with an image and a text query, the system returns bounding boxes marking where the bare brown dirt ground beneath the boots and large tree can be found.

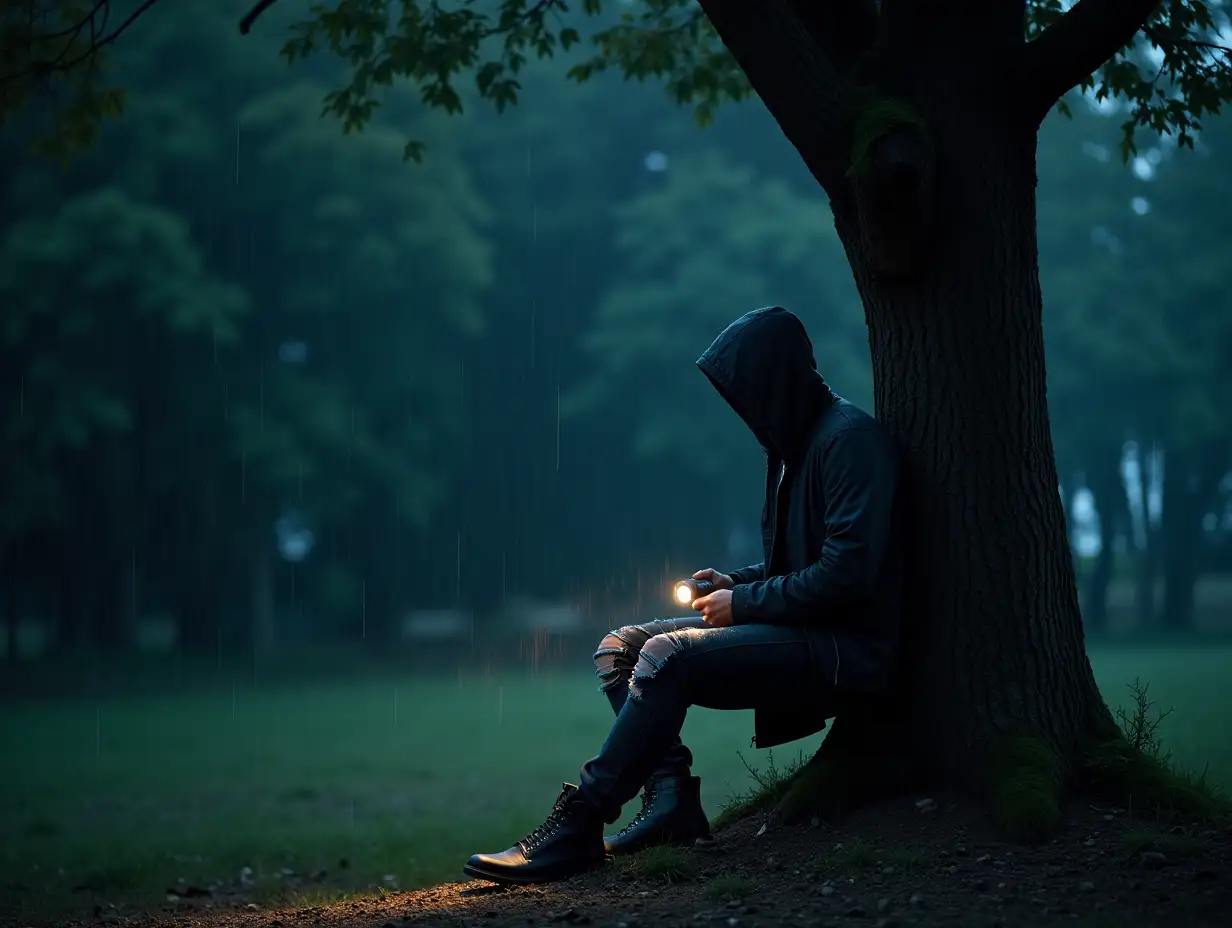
[26,799,1232,928]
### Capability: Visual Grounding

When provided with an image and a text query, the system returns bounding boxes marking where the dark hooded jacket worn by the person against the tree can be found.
[697,307,903,747]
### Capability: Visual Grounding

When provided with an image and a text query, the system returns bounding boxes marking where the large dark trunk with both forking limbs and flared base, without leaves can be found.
[701,0,1182,837]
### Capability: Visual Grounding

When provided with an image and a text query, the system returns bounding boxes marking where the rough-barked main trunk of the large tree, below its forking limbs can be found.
[839,119,1106,789]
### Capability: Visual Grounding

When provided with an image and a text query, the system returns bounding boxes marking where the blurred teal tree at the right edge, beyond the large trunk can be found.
[1090,108,1232,631]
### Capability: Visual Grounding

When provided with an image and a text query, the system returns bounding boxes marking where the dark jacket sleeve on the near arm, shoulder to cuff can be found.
[732,426,898,625]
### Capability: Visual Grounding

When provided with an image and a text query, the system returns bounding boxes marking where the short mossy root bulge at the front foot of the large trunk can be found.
[987,731,1066,843]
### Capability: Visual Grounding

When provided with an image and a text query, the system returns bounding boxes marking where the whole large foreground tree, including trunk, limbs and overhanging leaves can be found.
[12,0,1232,834]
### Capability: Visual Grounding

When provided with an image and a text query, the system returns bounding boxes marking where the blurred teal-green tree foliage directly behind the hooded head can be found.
[564,144,872,518]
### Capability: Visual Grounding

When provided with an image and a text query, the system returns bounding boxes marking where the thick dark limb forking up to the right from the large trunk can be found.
[1024,0,1159,120]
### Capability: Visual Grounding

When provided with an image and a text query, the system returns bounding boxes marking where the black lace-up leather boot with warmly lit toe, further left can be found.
[462,783,604,885]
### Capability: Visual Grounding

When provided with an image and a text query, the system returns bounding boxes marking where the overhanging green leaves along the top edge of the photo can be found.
[0,0,1232,165]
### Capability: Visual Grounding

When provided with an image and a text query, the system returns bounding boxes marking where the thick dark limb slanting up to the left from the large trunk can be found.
[699,0,872,196]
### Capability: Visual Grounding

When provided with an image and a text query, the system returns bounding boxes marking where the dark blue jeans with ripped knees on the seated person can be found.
[580,616,824,822]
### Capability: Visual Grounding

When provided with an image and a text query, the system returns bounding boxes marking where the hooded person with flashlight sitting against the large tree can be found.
[464,307,903,884]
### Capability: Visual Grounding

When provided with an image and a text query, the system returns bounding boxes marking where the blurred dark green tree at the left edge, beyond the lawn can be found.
[0,189,248,646]
